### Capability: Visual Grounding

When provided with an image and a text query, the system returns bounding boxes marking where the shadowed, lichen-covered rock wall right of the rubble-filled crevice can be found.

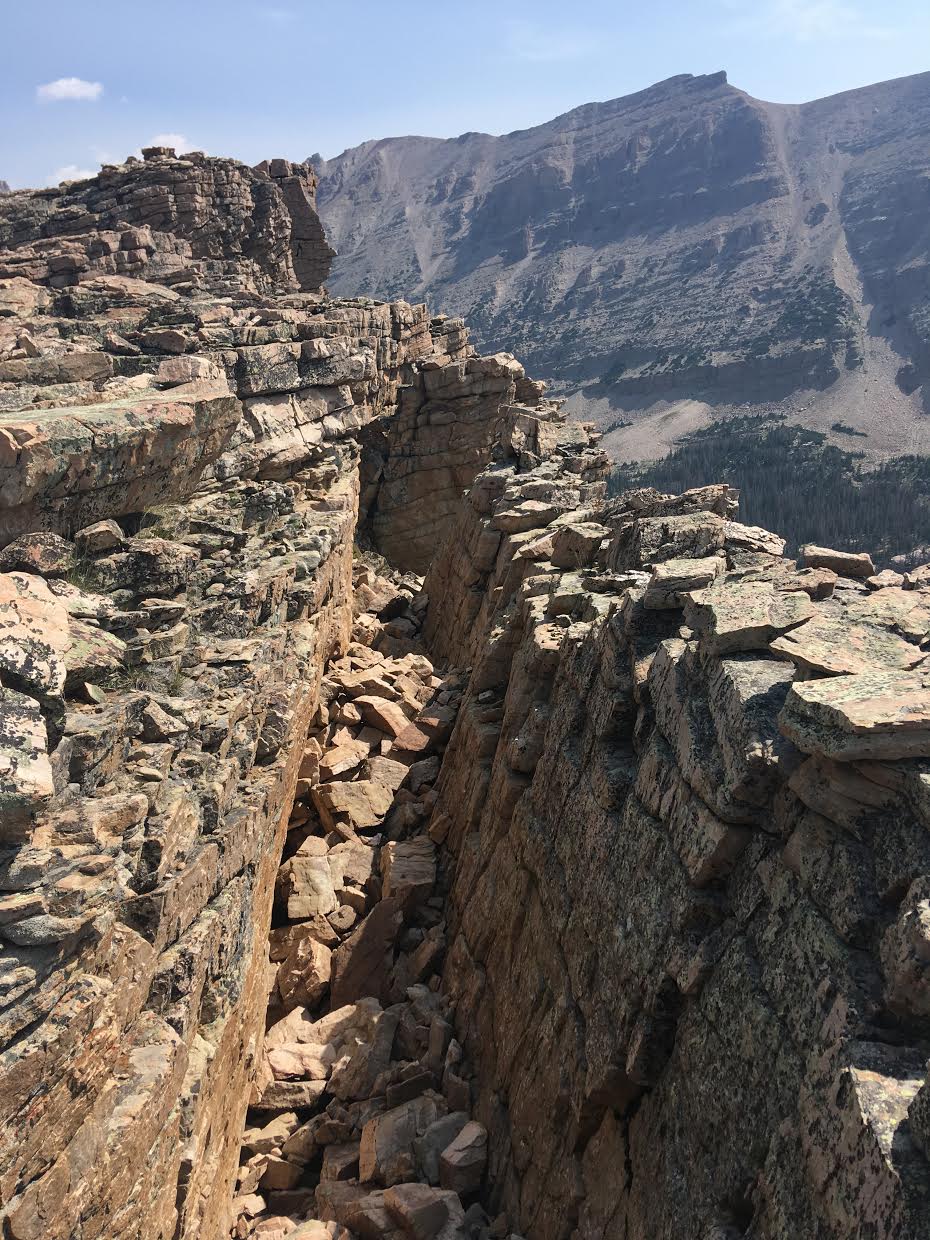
[425,458,930,1238]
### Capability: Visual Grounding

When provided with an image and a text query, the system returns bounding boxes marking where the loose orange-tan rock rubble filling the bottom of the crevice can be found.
[232,565,508,1240]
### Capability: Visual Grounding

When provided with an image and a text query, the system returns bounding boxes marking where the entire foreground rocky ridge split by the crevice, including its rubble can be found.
[0,138,930,1240]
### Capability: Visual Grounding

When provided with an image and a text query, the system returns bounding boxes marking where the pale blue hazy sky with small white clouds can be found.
[0,0,930,188]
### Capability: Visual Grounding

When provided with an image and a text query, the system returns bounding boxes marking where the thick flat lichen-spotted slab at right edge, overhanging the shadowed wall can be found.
[779,671,930,761]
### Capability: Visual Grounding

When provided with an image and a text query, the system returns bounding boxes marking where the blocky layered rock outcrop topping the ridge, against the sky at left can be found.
[0,146,334,293]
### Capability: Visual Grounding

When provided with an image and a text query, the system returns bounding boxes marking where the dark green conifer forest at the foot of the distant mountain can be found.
[608,415,930,563]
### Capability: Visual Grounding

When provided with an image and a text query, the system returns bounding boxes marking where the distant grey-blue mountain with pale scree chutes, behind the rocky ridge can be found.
[317,73,930,459]
